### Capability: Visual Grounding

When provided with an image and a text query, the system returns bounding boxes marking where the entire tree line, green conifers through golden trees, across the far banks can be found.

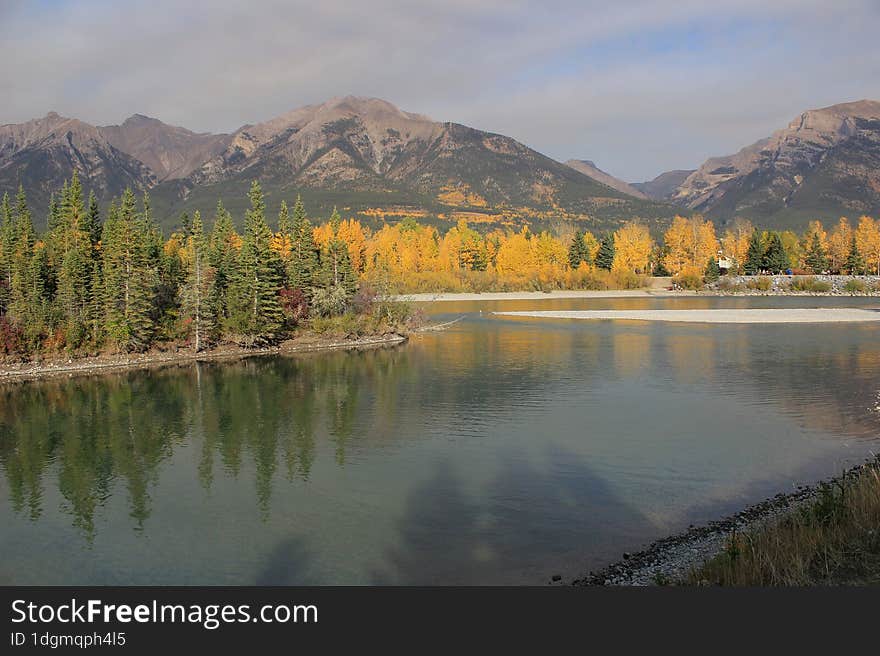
[0,174,880,355]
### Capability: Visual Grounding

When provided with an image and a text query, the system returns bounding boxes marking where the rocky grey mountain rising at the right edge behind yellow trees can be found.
[671,100,880,227]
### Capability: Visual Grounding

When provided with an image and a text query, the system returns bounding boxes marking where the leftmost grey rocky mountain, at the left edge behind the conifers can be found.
[0,112,158,210]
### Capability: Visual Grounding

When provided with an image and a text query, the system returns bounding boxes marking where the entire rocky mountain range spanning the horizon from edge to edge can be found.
[0,96,880,230]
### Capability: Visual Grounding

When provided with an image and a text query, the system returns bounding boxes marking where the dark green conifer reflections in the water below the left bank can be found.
[0,350,406,539]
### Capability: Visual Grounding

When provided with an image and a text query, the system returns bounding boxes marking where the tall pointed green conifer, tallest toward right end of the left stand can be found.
[228,181,284,346]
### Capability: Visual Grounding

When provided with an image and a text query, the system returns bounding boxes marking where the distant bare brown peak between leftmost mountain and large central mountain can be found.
[98,114,231,181]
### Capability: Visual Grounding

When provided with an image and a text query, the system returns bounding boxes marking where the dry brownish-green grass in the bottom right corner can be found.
[685,460,880,586]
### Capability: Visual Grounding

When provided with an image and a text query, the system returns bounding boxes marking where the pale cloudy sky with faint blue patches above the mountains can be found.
[0,0,880,181]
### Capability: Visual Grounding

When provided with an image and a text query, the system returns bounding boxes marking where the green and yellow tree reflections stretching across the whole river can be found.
[0,322,880,537]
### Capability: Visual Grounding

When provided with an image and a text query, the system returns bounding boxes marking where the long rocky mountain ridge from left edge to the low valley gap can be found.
[0,96,675,230]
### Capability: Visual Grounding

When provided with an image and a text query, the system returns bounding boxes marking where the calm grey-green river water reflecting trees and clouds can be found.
[0,297,880,585]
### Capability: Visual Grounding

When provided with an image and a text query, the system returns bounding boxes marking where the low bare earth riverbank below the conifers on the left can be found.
[0,333,408,384]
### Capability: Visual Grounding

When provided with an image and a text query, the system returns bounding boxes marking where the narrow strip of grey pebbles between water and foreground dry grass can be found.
[569,456,880,586]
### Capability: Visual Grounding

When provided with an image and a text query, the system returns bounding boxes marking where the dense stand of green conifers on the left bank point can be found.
[0,173,358,354]
